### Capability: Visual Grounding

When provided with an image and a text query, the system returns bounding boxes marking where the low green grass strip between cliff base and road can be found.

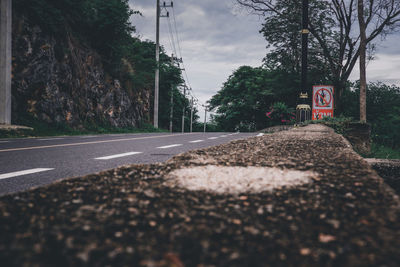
[0,118,166,138]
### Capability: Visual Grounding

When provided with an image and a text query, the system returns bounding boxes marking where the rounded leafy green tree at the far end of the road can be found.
[210,66,297,131]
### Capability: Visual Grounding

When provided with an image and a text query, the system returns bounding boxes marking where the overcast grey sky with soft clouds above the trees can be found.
[130,0,400,116]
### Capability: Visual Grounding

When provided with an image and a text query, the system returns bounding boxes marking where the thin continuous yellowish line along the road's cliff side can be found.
[0,134,187,152]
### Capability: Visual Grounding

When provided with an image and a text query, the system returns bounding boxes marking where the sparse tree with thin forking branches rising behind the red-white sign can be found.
[237,0,400,113]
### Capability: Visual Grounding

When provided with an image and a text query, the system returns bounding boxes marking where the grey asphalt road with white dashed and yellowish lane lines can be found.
[0,133,256,195]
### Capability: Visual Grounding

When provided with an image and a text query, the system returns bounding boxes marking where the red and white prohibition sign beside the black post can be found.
[312,85,334,120]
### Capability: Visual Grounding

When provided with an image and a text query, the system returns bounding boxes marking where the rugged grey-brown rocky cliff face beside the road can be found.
[12,18,150,128]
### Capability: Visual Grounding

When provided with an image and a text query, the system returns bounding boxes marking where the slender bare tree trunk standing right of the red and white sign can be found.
[358,0,367,122]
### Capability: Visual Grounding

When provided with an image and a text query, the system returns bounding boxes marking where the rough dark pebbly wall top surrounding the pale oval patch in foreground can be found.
[0,125,400,266]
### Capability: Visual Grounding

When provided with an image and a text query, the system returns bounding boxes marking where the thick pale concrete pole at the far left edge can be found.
[0,0,12,124]
